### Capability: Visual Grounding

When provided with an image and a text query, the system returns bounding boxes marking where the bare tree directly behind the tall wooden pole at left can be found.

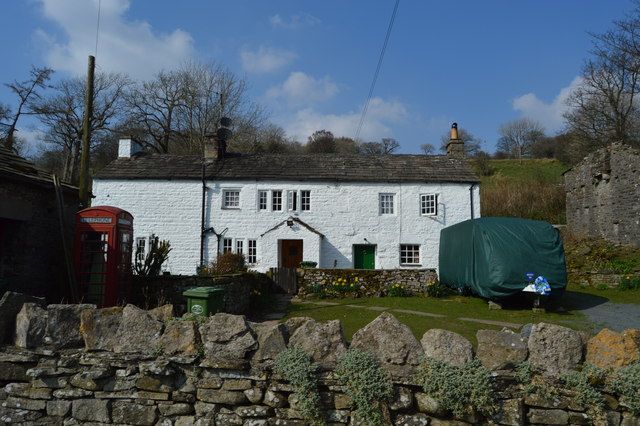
[34,73,130,183]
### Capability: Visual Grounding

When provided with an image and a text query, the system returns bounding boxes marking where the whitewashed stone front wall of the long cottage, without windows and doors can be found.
[93,180,480,274]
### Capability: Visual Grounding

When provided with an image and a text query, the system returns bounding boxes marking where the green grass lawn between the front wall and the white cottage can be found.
[285,296,591,345]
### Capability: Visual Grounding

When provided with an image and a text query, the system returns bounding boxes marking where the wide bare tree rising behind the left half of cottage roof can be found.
[127,62,266,154]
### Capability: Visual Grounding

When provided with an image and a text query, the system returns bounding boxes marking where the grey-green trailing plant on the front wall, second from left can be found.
[336,349,393,425]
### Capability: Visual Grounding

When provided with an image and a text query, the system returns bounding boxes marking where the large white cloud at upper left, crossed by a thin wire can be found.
[36,0,194,78]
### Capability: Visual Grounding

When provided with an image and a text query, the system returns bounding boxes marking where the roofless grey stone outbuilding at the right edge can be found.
[564,142,640,247]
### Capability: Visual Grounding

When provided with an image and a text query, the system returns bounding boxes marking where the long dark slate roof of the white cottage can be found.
[95,153,479,183]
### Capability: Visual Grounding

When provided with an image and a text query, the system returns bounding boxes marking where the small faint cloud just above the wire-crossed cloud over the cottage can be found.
[266,71,340,106]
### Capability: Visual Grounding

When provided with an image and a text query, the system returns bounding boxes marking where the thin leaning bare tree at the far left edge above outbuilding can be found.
[0,67,53,149]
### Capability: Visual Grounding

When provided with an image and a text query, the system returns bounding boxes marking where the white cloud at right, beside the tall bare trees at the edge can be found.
[512,77,582,132]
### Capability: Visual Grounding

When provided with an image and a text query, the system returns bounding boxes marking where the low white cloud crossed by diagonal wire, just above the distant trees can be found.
[284,98,409,142]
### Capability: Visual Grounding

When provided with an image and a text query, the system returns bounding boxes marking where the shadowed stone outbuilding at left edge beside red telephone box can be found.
[0,146,78,300]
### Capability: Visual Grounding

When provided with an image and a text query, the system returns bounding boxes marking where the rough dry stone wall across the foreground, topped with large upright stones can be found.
[0,303,640,426]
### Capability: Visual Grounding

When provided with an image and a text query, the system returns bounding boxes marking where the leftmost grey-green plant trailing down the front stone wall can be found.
[274,346,322,423]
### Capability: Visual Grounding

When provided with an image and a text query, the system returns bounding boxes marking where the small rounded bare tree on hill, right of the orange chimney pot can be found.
[497,118,544,160]
